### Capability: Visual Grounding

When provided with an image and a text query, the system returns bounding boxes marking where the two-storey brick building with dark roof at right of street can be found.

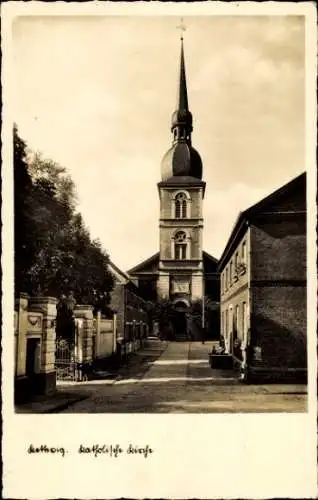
[218,174,307,379]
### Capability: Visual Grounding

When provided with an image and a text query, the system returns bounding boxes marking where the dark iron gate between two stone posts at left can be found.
[55,337,82,381]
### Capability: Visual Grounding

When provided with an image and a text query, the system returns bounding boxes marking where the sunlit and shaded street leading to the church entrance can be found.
[58,340,307,413]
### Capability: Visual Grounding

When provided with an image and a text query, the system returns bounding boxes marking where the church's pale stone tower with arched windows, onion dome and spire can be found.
[157,37,205,307]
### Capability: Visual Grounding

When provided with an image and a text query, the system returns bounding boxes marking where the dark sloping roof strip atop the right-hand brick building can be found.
[218,172,306,271]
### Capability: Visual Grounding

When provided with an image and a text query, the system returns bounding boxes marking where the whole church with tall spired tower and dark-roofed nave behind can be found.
[128,37,220,338]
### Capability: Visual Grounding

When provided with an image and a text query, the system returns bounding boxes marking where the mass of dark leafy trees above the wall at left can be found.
[14,129,113,310]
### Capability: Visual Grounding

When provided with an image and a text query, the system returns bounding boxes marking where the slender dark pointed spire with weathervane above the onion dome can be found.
[171,26,192,144]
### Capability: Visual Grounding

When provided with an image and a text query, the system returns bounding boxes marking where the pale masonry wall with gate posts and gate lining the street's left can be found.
[14,294,147,402]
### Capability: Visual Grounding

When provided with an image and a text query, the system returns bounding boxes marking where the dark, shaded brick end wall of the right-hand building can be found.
[251,215,307,369]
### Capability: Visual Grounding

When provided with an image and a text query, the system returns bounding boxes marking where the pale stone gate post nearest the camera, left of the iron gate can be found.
[29,297,57,394]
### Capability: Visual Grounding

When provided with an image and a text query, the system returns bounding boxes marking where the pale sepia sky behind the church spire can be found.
[12,15,305,270]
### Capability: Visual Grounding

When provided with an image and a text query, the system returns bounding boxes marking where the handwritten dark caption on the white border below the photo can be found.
[27,444,153,458]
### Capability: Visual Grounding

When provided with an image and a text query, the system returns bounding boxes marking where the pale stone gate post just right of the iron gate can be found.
[74,305,94,376]
